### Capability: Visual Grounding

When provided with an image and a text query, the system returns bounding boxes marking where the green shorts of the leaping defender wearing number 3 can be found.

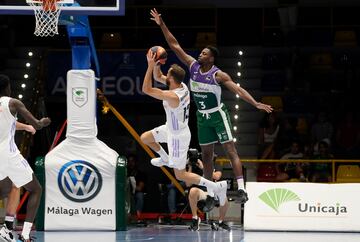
[196,105,233,145]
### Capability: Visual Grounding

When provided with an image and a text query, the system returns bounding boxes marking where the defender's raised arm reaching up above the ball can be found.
[150,8,195,66]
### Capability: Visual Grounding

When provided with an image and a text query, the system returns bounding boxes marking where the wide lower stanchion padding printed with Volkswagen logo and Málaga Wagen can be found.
[45,138,118,230]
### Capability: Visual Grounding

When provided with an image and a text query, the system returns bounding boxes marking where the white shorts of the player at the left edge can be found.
[0,154,33,188]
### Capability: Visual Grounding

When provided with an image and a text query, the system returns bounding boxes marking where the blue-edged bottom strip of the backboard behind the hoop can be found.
[0,0,125,15]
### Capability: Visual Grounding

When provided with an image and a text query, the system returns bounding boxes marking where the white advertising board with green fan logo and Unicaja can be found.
[244,182,360,232]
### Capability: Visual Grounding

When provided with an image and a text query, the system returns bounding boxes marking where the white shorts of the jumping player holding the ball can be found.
[151,125,191,170]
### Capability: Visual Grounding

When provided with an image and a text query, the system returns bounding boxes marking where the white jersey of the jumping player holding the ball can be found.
[163,82,190,134]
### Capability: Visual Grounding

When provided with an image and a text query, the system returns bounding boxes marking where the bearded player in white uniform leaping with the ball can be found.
[141,53,227,204]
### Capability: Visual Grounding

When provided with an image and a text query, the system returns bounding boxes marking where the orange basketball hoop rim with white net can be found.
[26,0,73,37]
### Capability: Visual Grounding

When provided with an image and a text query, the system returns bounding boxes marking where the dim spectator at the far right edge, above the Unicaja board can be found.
[336,111,360,159]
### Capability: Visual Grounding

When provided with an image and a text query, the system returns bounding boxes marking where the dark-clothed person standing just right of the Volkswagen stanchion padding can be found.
[127,155,146,224]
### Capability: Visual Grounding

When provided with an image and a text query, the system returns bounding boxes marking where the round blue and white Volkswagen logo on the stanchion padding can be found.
[58,160,102,202]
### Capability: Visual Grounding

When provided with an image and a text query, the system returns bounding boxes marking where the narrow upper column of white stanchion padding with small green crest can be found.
[66,70,97,138]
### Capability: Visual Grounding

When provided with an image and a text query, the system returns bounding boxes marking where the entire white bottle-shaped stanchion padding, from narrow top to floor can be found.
[44,70,118,230]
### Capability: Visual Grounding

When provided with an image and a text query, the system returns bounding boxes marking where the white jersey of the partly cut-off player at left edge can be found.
[0,97,20,158]
